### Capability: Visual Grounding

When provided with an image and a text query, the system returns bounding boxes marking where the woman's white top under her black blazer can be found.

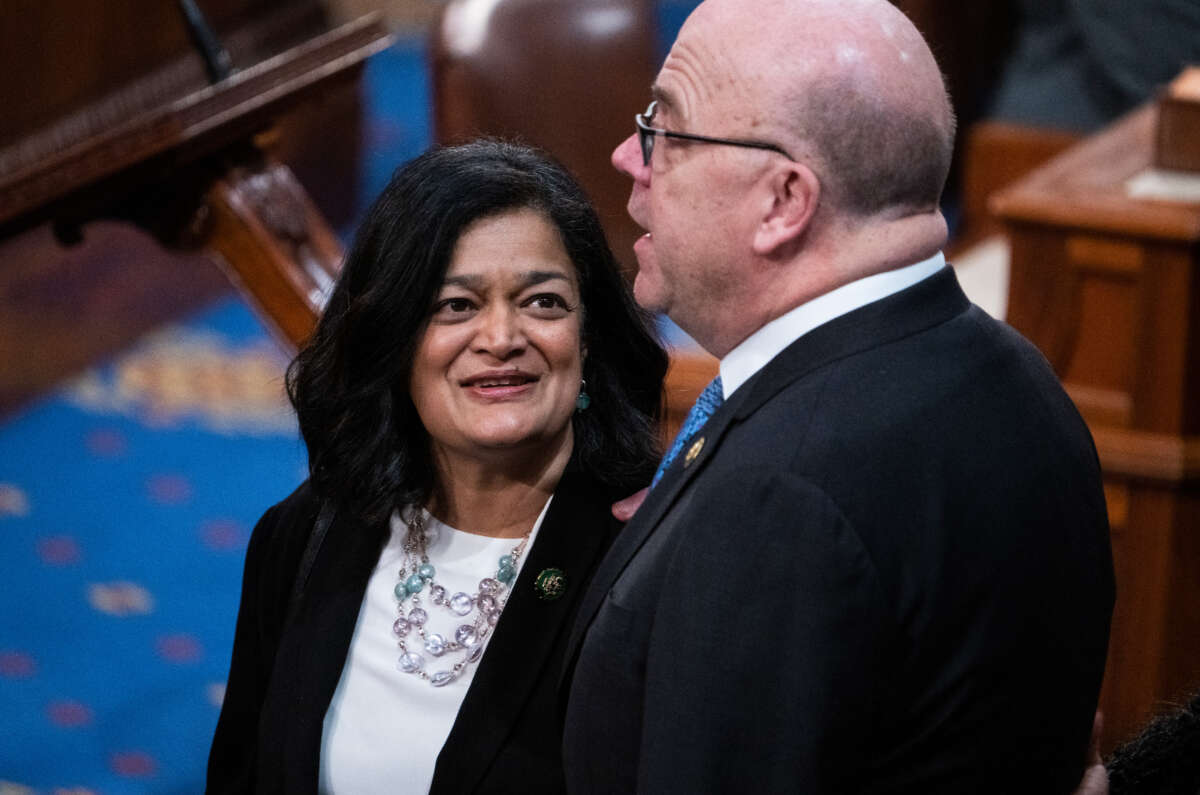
[313,501,550,795]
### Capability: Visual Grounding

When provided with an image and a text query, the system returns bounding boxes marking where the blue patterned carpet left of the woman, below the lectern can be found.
[0,299,305,795]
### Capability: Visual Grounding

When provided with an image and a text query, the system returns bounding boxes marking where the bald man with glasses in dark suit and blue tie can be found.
[564,0,1114,794]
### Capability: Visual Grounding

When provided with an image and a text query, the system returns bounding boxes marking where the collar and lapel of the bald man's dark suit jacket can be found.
[560,267,971,687]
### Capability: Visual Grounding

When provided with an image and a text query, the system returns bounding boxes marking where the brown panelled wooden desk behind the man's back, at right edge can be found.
[991,106,1200,749]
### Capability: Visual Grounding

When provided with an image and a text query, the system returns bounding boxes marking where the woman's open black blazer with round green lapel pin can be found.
[208,461,625,795]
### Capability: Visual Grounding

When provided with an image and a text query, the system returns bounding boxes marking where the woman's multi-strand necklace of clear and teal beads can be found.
[391,507,533,687]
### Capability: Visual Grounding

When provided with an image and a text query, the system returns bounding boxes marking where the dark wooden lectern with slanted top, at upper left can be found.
[0,0,391,389]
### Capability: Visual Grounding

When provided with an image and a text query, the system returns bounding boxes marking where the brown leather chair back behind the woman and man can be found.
[431,0,659,279]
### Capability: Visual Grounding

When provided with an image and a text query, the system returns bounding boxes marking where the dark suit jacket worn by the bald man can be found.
[564,269,1114,795]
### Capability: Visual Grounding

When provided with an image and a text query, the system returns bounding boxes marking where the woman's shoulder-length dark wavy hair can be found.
[287,141,667,522]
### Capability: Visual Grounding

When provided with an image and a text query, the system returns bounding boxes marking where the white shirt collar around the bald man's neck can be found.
[721,251,946,400]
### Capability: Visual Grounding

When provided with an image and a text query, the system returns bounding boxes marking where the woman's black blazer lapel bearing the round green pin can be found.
[431,470,616,793]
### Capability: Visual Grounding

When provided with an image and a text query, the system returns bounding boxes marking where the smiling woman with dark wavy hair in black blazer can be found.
[201,142,666,794]
